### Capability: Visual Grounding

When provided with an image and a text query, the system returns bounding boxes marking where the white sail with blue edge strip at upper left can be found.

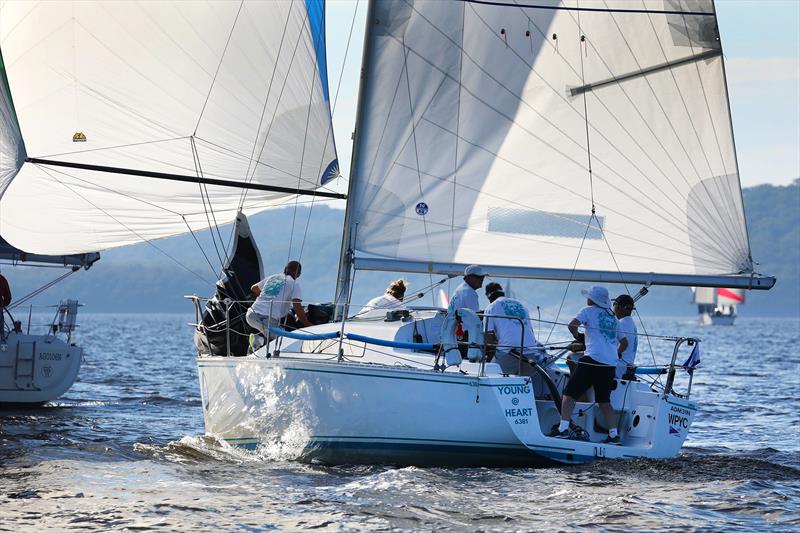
[0,0,338,254]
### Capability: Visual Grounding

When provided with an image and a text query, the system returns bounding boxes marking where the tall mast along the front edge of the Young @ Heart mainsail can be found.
[335,0,373,320]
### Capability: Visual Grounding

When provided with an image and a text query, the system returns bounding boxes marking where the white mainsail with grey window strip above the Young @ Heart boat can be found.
[349,0,752,282]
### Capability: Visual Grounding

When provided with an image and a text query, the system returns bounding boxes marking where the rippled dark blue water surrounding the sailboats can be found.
[0,315,800,531]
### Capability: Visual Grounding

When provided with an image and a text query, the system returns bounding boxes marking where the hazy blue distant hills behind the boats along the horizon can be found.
[3,180,800,317]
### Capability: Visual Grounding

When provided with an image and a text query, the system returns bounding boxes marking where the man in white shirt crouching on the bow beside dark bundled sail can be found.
[245,261,313,339]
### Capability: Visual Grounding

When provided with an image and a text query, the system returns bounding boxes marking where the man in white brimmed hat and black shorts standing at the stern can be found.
[552,286,620,444]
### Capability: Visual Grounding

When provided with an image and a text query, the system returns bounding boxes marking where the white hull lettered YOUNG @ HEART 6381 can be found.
[197,316,697,466]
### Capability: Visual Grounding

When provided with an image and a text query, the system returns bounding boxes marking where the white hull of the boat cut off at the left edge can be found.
[0,332,83,405]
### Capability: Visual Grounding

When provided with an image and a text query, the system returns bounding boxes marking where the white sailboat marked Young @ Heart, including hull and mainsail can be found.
[198,1,774,465]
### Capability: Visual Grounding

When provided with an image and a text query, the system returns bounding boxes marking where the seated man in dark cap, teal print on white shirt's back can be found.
[483,283,542,374]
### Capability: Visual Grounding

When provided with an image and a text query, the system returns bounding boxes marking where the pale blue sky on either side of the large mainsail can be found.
[327,0,800,192]
